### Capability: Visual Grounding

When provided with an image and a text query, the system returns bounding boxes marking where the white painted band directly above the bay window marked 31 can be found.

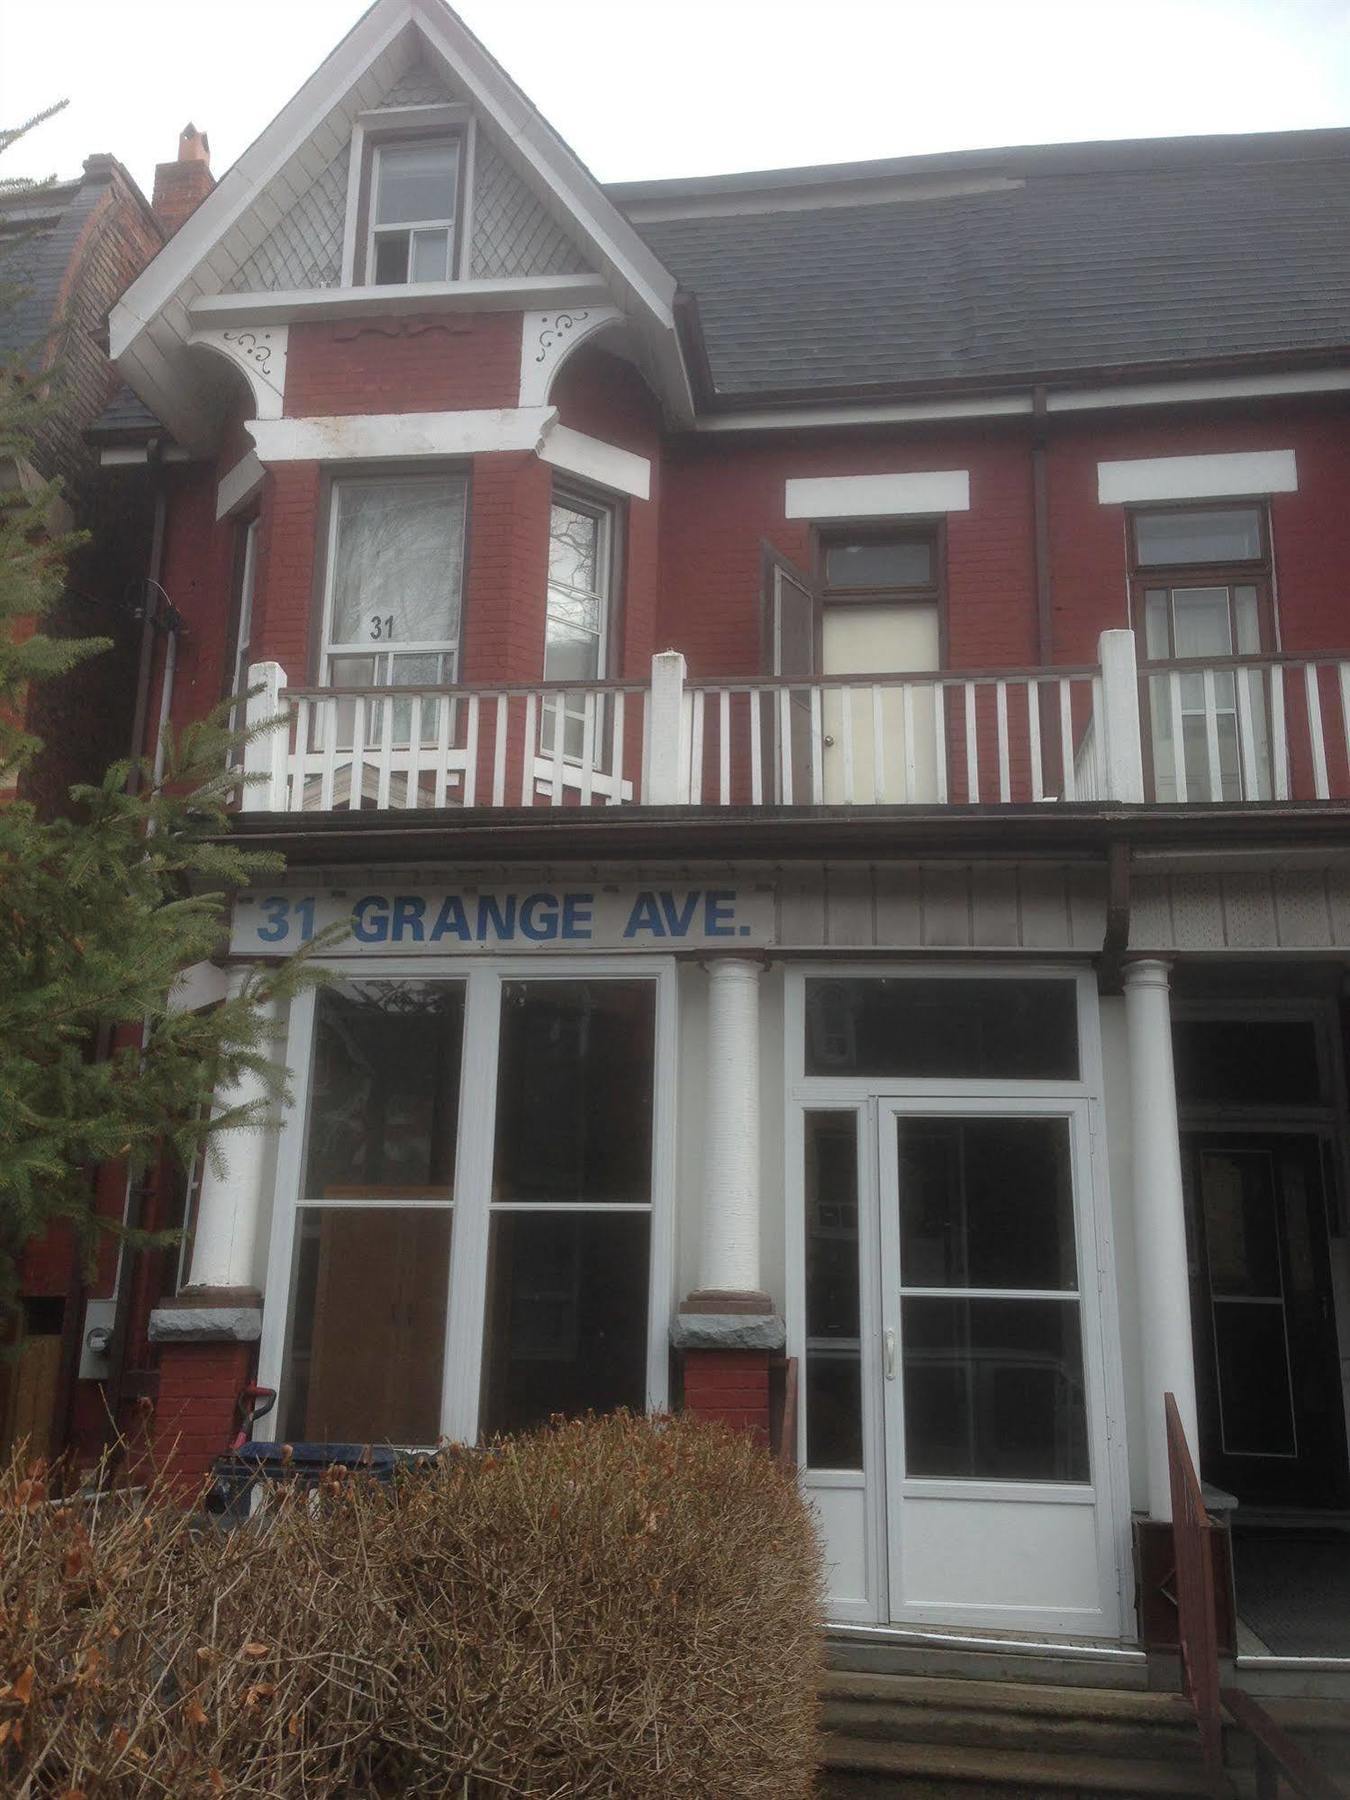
[245,407,558,464]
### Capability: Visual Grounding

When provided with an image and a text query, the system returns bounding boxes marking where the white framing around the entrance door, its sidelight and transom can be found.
[783,959,1132,1634]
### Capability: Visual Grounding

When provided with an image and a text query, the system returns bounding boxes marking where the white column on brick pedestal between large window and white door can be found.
[698,956,760,1300]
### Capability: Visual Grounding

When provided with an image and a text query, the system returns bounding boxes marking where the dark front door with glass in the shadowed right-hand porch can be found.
[1184,1132,1350,1517]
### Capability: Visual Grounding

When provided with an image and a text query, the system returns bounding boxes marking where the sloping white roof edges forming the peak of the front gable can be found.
[110,0,689,443]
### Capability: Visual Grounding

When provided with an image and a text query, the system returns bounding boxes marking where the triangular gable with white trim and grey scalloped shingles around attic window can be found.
[110,0,689,443]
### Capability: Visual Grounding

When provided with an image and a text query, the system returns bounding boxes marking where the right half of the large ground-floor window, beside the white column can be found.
[481,981,655,1436]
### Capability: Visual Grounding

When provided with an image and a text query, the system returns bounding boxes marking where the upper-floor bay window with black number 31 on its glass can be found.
[322,475,466,712]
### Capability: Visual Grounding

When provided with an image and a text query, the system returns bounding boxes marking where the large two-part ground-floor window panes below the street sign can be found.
[273,965,662,1445]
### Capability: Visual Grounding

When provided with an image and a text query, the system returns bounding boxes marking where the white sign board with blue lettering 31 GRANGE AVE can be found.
[230,884,774,956]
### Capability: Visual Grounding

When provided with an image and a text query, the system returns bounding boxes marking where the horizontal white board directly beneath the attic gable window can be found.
[189,275,610,326]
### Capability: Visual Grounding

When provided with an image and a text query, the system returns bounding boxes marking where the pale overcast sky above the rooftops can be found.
[0,0,1350,193]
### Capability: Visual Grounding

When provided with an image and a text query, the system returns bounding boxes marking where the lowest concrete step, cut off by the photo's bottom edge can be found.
[821,1732,1208,1800]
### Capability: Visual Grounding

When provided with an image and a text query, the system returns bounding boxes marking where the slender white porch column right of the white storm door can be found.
[1125,961,1199,1519]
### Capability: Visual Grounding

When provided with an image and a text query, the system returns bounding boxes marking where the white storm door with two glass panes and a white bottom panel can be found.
[878,1100,1112,1631]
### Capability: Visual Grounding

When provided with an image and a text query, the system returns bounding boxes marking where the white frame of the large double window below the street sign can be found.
[254,954,679,1444]
